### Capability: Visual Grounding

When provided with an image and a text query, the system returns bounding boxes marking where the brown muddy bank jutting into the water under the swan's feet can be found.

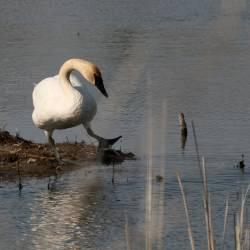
[0,131,135,178]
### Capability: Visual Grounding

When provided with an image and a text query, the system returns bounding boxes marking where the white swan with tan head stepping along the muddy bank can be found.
[32,59,121,162]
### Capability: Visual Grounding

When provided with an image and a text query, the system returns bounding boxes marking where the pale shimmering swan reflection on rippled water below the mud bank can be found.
[29,169,102,249]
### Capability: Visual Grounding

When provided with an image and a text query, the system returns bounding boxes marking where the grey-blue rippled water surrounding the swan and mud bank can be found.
[0,0,250,250]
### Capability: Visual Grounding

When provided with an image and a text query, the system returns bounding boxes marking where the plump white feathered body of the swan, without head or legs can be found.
[32,74,97,131]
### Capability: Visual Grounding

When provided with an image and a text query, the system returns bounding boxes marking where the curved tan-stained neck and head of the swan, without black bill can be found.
[59,59,94,92]
